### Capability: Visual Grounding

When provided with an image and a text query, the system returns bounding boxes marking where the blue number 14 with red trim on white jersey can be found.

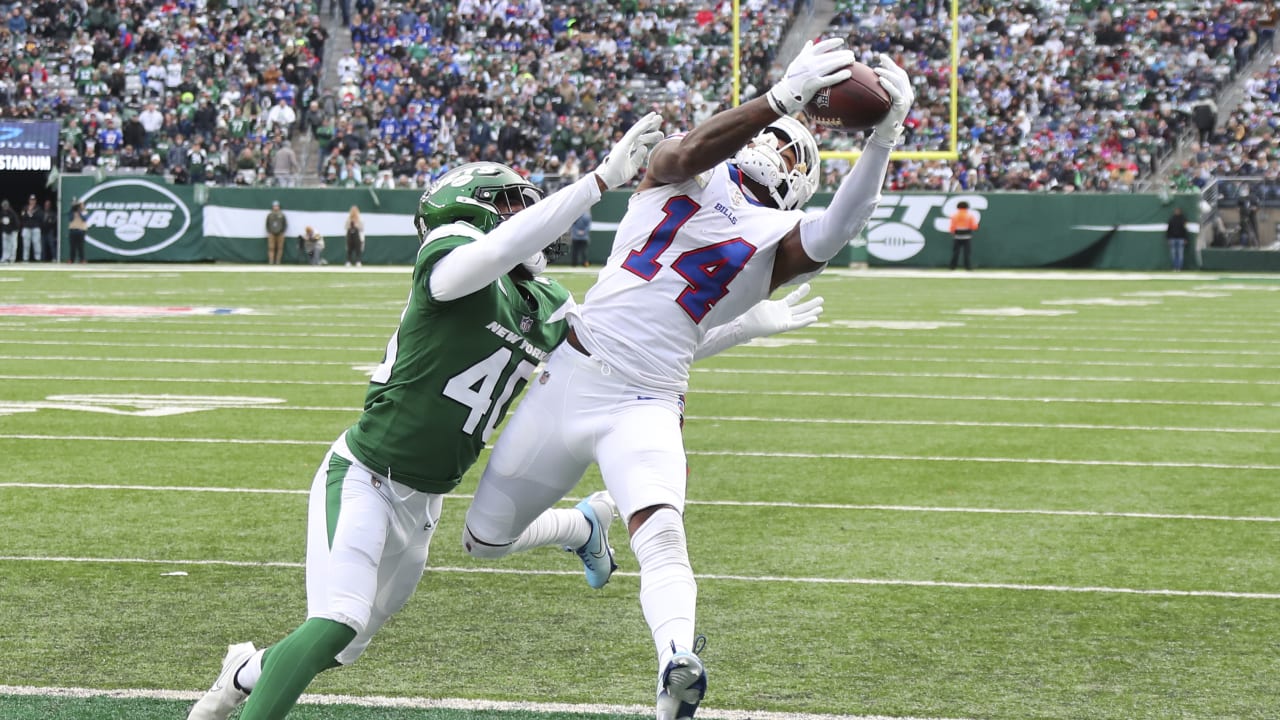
[622,195,755,323]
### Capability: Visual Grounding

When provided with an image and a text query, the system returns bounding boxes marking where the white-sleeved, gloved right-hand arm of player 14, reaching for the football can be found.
[772,55,915,288]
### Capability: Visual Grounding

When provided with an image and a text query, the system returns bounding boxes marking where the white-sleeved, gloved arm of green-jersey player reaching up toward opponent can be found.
[429,113,662,301]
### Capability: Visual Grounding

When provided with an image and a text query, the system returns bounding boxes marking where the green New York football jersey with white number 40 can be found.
[347,225,573,493]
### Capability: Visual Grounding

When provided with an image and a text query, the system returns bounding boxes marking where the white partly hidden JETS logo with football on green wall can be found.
[867,195,987,263]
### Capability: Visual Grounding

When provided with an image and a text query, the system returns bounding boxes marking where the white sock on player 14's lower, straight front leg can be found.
[631,507,698,673]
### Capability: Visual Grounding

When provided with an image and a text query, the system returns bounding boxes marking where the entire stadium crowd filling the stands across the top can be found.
[0,0,1280,191]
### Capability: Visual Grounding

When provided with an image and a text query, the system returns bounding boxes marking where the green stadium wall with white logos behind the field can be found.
[59,176,1199,270]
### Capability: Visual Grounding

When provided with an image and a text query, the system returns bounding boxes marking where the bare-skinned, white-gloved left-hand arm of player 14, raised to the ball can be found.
[640,37,855,190]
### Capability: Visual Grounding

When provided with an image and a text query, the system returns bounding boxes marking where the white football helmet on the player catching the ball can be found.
[733,117,819,210]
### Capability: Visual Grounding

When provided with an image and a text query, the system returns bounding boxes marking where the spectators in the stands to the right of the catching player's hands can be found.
[826,0,1280,192]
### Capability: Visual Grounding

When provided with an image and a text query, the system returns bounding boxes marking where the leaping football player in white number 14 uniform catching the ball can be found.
[463,38,914,720]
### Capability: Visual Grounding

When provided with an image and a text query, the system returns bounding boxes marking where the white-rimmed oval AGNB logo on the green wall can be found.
[81,179,191,258]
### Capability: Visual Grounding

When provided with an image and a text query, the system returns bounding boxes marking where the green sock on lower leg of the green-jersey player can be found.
[241,618,356,720]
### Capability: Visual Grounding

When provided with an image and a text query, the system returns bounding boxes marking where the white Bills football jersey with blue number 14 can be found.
[571,163,804,392]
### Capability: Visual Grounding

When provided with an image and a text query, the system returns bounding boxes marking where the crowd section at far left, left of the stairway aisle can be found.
[0,0,328,184]
